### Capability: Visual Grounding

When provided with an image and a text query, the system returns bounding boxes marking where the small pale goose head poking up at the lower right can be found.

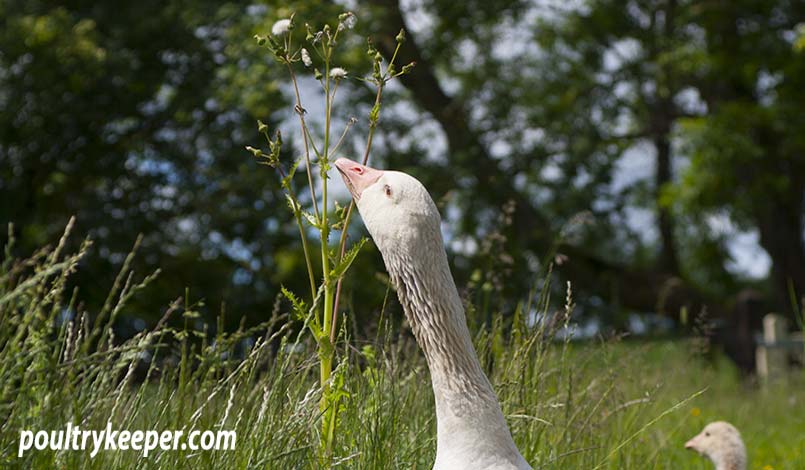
[685,421,746,470]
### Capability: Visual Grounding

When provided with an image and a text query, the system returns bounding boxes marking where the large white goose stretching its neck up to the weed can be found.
[335,158,531,470]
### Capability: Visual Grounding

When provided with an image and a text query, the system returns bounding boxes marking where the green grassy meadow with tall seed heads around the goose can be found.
[0,225,805,469]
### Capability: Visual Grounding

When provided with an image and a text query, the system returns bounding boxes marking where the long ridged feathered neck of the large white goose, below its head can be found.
[383,232,530,462]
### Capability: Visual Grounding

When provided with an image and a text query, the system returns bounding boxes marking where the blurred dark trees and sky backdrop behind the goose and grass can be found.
[0,0,805,372]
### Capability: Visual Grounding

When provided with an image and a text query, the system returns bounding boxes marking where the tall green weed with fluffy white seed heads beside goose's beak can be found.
[247,12,413,465]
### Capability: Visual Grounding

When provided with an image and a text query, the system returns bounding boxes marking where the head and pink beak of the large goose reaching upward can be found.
[335,158,441,254]
